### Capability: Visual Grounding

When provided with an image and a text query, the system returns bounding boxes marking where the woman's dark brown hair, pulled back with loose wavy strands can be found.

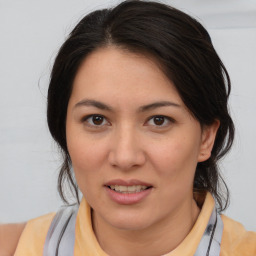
[47,0,234,210]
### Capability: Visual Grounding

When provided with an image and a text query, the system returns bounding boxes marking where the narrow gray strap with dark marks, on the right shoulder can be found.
[194,208,223,256]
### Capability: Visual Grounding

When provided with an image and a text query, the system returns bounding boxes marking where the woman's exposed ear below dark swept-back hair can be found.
[198,120,220,162]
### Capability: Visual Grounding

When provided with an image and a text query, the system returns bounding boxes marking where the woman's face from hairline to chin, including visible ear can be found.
[66,47,217,230]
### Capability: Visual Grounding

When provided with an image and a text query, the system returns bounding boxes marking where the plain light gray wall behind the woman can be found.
[0,0,256,231]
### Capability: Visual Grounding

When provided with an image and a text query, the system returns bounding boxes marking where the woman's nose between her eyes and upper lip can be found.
[108,127,146,171]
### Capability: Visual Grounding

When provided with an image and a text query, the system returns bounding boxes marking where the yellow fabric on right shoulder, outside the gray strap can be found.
[221,215,256,256]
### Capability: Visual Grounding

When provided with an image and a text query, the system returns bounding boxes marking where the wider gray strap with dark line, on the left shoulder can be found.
[43,205,78,256]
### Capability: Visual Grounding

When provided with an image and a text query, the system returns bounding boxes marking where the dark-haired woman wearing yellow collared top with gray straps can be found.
[1,1,256,256]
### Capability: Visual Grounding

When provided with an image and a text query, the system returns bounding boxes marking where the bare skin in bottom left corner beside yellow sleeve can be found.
[0,223,26,256]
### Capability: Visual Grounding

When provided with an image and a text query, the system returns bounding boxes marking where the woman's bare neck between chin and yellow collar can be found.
[92,200,200,256]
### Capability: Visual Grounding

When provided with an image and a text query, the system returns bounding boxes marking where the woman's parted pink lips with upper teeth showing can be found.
[105,180,153,205]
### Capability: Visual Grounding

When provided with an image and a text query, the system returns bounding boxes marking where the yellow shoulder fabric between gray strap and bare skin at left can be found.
[14,213,55,256]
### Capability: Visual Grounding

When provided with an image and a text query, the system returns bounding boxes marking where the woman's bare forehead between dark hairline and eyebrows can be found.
[71,47,182,107]
